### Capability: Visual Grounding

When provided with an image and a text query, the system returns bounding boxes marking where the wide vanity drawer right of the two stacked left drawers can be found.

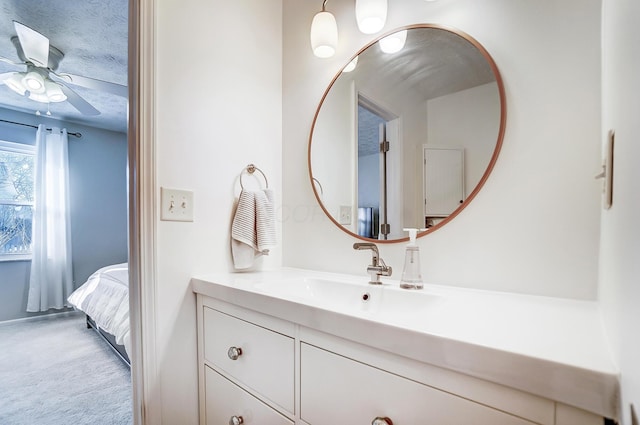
[300,343,532,425]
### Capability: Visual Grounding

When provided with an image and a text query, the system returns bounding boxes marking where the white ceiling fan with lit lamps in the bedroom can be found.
[0,21,128,115]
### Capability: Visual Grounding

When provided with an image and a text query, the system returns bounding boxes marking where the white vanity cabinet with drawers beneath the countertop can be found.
[197,293,603,425]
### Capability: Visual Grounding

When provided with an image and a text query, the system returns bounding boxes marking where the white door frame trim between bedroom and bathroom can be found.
[127,0,162,425]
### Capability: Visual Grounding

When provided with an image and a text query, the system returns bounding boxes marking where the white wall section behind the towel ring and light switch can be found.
[155,0,282,424]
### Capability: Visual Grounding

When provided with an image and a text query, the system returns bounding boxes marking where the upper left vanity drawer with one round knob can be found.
[204,307,295,413]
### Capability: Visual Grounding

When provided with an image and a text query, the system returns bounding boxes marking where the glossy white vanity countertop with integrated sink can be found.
[191,268,619,417]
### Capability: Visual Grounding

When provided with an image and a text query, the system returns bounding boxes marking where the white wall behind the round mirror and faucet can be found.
[283,0,601,299]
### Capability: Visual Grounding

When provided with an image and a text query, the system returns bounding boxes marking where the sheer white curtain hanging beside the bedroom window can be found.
[27,125,73,311]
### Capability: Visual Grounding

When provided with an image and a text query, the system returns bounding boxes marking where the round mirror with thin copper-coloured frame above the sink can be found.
[308,24,506,242]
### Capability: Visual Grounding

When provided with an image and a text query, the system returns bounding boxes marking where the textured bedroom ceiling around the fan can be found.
[0,0,128,132]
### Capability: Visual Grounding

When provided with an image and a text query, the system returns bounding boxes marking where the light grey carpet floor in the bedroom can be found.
[0,313,133,425]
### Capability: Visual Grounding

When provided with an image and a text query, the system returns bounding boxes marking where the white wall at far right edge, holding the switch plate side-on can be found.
[599,0,640,425]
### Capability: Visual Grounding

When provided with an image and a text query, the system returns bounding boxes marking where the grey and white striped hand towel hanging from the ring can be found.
[231,189,276,269]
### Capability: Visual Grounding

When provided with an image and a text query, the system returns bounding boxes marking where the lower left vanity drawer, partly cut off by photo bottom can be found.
[205,367,293,425]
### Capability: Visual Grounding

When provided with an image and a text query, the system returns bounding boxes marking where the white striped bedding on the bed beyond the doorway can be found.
[68,263,131,354]
